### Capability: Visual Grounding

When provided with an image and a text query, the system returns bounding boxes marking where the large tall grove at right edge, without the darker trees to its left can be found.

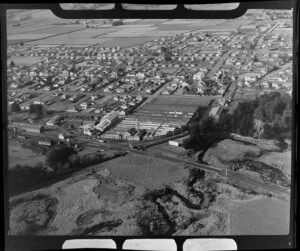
[218,92,292,139]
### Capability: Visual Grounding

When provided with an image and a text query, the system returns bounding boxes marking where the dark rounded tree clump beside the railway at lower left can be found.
[45,146,74,171]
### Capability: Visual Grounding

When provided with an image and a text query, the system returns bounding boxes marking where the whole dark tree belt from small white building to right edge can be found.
[184,92,292,150]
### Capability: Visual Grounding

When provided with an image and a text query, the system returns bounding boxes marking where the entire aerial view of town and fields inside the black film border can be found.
[6,4,293,236]
